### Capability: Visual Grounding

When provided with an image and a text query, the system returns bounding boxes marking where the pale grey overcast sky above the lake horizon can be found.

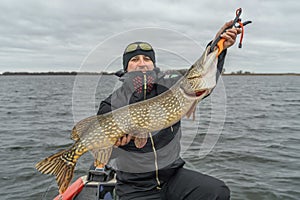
[0,0,300,73]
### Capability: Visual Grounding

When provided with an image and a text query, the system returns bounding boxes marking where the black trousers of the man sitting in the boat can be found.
[120,168,230,200]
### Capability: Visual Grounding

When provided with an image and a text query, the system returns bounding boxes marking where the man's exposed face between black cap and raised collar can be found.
[127,55,154,72]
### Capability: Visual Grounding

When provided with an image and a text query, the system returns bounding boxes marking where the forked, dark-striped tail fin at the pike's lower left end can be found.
[35,150,76,194]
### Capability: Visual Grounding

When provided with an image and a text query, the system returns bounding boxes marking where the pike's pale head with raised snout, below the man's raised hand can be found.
[180,47,218,99]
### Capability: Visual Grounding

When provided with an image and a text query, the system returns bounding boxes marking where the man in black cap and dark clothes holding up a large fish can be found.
[97,21,241,200]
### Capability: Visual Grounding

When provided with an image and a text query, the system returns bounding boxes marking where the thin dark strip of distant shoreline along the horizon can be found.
[0,70,300,76]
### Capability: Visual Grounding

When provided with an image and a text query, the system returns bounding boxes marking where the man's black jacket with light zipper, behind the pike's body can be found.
[97,50,226,196]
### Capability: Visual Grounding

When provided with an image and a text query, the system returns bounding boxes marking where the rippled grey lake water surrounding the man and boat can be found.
[0,76,300,200]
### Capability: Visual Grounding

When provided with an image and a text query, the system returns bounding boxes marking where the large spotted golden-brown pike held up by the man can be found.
[35,47,218,193]
